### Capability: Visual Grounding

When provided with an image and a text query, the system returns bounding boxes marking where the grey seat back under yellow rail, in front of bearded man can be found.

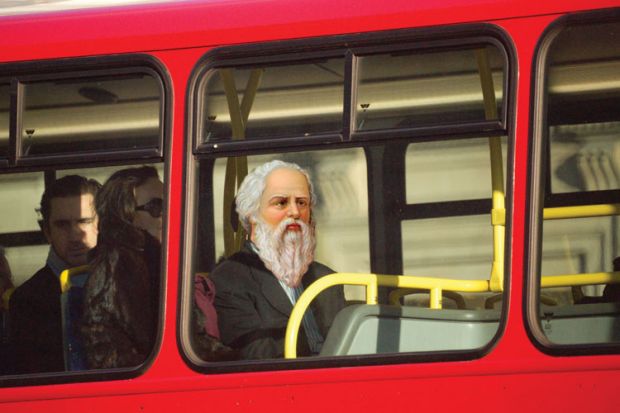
[321,304,500,356]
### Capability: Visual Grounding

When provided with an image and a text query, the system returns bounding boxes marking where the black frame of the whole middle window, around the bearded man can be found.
[182,23,518,374]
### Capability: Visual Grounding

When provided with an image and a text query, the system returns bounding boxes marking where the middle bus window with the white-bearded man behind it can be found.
[183,30,509,370]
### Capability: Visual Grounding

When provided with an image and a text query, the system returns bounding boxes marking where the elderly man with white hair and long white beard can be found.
[210,160,344,359]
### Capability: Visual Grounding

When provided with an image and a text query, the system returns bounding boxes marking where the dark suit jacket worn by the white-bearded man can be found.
[210,244,344,359]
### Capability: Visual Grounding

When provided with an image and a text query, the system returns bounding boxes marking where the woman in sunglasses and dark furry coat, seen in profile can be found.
[82,166,163,369]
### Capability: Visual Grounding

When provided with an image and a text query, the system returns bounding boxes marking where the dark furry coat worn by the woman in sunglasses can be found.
[81,233,161,369]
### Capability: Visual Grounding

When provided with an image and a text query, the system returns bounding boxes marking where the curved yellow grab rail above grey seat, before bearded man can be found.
[284,273,489,358]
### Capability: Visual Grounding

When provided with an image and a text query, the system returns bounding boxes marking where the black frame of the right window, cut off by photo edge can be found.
[523,9,620,357]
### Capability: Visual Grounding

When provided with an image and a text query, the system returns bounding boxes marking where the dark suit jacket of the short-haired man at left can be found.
[9,265,65,373]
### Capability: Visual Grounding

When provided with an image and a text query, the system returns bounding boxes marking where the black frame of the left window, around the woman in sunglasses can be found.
[0,54,173,387]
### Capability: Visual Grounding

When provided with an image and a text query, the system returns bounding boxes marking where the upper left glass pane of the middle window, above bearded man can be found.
[199,58,344,142]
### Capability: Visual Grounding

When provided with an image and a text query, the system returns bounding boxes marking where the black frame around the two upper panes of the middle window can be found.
[188,24,516,155]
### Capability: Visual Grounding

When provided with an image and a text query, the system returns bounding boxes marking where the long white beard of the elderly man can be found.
[254,218,316,288]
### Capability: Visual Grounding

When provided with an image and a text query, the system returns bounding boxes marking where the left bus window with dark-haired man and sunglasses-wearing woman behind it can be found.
[0,59,166,382]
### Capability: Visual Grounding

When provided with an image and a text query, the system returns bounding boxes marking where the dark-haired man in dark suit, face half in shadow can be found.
[9,175,100,374]
